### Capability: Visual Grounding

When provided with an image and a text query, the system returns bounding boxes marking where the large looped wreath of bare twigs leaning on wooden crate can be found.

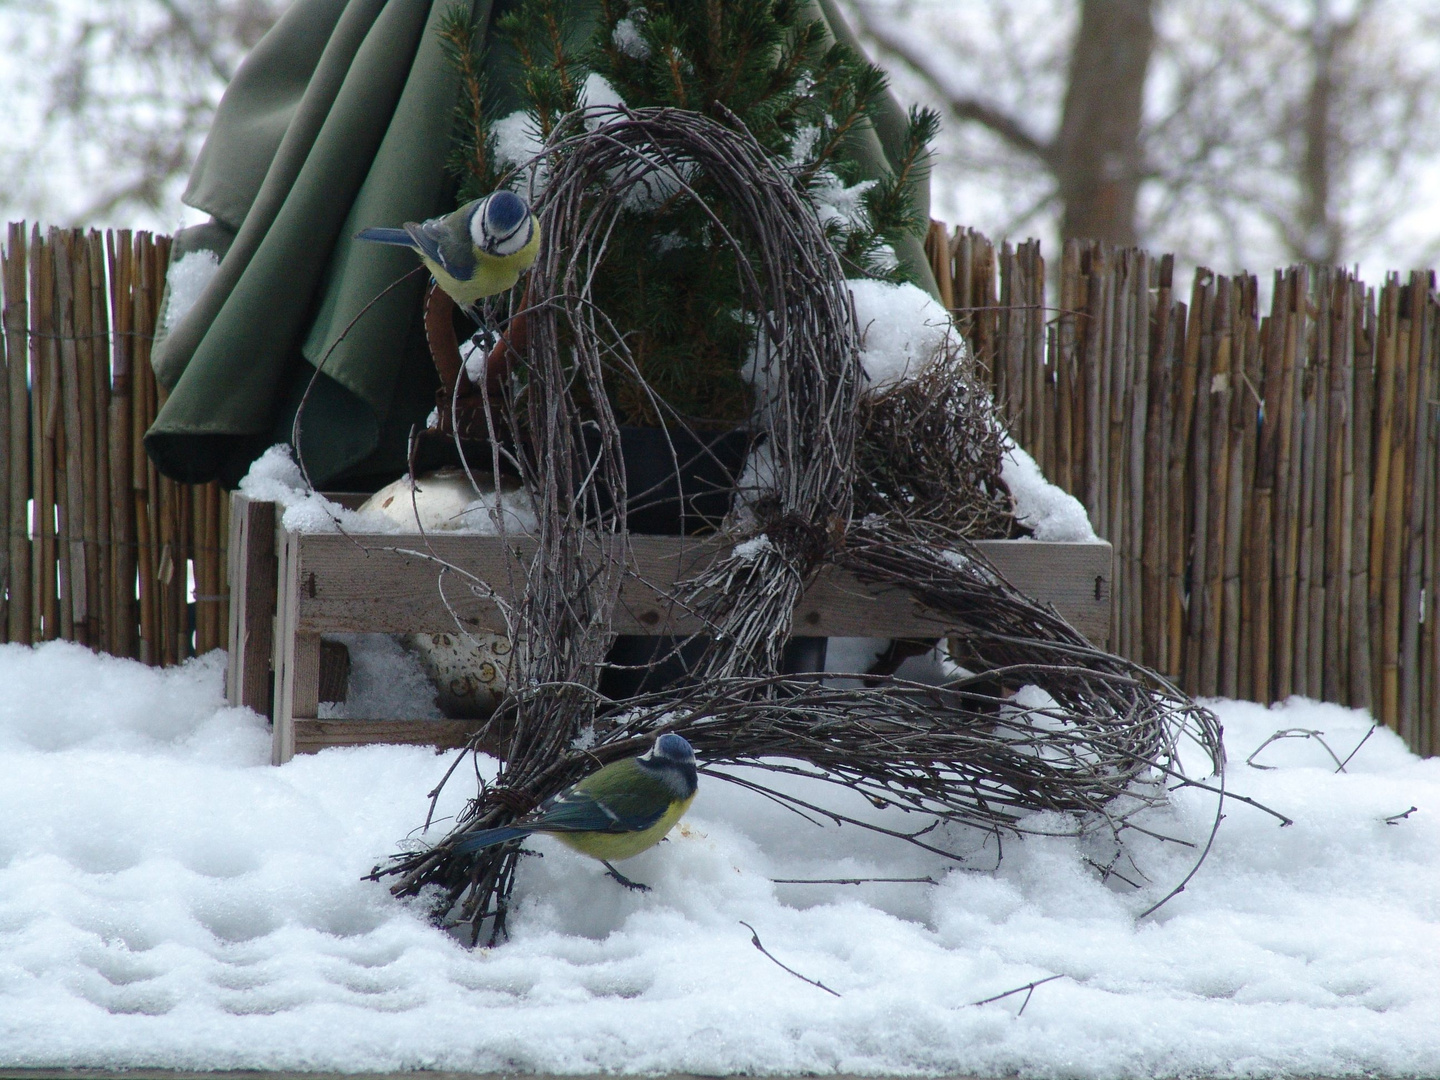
[373,108,1223,942]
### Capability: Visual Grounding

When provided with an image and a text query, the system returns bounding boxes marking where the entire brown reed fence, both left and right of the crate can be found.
[0,223,1440,755]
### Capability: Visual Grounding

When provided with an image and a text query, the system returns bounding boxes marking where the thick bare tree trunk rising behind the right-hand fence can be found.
[1051,0,1155,246]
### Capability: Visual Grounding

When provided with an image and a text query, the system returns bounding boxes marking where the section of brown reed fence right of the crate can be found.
[927,223,1440,755]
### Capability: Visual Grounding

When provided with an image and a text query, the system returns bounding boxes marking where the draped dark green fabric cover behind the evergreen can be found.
[145,0,933,487]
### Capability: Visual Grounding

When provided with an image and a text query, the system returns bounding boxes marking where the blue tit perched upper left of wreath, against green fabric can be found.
[356,190,540,321]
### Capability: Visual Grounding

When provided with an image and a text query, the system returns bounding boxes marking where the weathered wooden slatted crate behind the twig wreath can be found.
[226,494,1112,765]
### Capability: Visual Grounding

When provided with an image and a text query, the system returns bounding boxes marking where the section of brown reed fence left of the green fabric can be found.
[0,223,229,664]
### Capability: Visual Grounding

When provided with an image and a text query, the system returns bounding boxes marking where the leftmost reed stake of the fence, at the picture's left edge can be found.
[4,222,32,644]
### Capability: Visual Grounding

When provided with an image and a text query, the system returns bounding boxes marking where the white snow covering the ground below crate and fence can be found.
[0,644,1440,1077]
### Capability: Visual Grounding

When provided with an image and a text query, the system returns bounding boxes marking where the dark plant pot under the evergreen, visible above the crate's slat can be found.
[585,425,750,536]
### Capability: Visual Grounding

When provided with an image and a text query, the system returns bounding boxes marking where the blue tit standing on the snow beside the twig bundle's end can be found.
[454,733,697,890]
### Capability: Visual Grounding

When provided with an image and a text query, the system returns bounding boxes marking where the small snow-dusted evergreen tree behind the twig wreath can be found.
[444,0,937,428]
